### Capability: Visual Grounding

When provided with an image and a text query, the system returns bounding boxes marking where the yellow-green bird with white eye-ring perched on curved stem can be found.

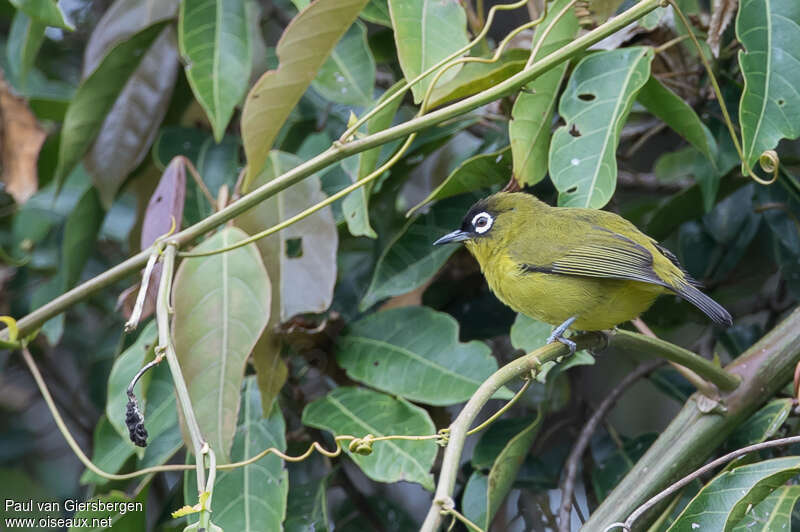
[434,192,732,351]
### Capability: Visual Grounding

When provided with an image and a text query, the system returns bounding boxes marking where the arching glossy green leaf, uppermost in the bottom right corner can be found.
[669,456,800,532]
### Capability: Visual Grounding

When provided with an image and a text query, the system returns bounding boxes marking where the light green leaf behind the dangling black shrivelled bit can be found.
[105,321,157,448]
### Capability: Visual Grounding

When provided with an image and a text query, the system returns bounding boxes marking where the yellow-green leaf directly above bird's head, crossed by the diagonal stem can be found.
[508,0,578,186]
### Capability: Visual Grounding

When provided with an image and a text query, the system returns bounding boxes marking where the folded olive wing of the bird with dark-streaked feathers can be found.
[512,226,669,286]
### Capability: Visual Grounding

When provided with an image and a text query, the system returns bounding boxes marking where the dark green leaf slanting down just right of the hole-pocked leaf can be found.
[636,76,717,165]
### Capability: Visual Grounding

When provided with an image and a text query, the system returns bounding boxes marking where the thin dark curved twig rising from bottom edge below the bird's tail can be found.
[558,360,664,532]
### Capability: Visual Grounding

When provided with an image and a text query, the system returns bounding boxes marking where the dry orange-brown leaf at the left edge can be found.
[0,76,47,204]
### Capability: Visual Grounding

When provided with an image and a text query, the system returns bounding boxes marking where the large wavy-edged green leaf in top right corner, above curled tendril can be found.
[736,0,800,167]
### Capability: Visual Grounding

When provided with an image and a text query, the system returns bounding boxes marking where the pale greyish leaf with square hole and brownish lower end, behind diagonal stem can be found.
[236,151,338,415]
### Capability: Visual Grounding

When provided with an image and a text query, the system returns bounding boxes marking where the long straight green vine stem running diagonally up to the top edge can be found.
[0,0,663,338]
